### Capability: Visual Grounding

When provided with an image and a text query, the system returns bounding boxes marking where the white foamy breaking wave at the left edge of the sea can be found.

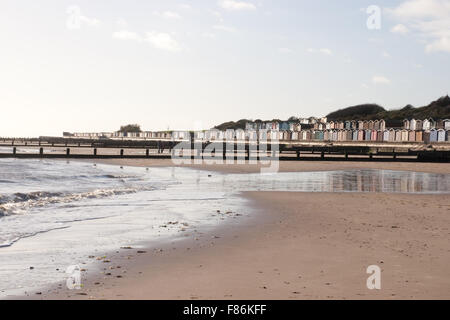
[0,187,155,217]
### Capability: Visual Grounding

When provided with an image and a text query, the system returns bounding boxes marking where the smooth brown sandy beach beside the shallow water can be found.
[20,160,450,299]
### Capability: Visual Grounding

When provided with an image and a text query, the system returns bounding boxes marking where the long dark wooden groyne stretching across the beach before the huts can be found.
[0,138,450,162]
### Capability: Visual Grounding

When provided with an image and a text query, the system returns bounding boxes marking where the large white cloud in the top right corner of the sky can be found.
[386,0,450,52]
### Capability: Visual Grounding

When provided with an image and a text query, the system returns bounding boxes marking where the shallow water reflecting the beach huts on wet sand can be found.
[197,169,450,193]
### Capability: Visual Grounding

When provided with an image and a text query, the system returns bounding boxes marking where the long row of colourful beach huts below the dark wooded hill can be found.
[64,118,450,143]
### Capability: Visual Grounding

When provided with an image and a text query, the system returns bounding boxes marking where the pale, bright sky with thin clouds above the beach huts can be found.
[0,0,450,137]
